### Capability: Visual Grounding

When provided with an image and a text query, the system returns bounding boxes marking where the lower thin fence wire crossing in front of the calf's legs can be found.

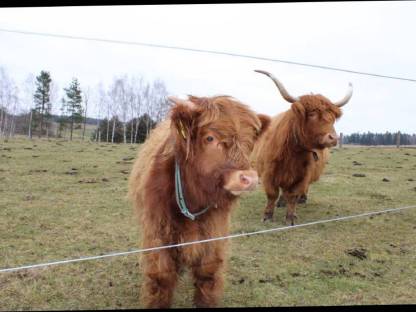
[0,205,416,273]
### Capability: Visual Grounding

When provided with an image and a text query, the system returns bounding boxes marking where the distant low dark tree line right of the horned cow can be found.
[343,131,416,145]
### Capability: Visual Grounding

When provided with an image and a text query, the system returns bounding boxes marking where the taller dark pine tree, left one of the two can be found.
[33,70,52,137]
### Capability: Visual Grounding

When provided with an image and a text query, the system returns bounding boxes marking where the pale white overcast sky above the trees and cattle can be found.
[0,1,416,133]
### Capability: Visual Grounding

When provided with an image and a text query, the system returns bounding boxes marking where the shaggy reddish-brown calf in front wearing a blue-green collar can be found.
[129,96,270,308]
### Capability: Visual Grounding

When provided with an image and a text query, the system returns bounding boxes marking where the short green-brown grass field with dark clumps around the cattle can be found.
[0,138,416,310]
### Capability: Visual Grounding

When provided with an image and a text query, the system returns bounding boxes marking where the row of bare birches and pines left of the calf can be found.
[0,67,169,143]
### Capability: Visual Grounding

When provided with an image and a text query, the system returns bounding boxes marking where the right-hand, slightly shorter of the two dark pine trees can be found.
[64,78,83,141]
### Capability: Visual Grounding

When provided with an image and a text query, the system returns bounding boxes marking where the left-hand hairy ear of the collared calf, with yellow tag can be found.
[169,97,200,159]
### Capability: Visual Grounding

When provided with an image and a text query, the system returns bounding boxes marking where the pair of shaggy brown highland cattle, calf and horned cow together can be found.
[129,70,352,308]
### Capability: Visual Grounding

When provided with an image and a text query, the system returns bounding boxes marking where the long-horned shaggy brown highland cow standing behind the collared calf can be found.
[252,70,352,225]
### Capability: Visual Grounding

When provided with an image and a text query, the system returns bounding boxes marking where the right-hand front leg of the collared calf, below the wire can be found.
[192,248,224,307]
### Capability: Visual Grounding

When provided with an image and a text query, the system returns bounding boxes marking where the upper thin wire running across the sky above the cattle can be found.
[0,28,416,82]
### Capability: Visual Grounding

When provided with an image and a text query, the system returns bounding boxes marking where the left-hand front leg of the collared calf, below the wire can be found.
[142,250,179,308]
